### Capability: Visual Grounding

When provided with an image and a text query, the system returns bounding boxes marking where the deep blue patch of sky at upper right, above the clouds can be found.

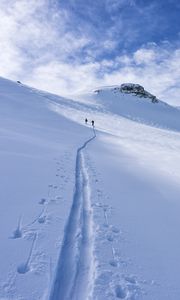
[59,0,180,59]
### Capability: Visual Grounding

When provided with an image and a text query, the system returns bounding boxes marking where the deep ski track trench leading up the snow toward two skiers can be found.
[49,128,96,300]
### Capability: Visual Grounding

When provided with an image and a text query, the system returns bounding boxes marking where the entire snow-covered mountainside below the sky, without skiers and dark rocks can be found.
[0,78,180,300]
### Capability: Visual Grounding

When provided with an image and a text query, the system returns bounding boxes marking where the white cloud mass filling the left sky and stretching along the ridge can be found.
[0,0,180,105]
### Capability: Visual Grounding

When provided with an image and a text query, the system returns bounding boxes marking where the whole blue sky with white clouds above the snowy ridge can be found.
[0,0,180,105]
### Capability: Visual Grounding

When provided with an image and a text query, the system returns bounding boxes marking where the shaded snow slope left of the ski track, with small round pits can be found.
[0,79,92,299]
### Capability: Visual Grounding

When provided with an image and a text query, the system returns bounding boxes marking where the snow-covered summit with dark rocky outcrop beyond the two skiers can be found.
[76,83,180,131]
